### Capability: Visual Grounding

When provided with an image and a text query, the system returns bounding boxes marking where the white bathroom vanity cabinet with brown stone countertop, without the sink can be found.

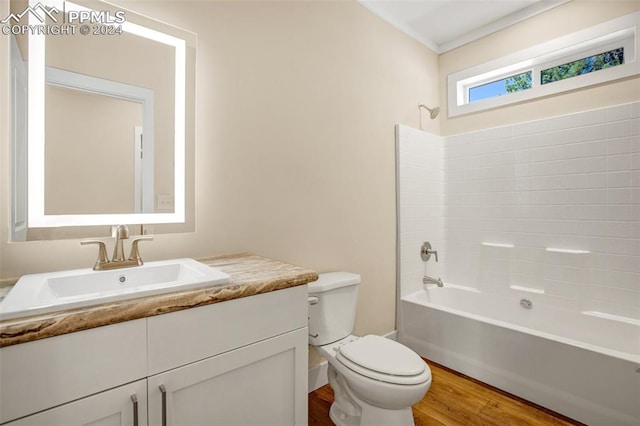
[0,255,317,426]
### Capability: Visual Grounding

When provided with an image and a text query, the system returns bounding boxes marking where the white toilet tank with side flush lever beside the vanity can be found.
[308,272,360,346]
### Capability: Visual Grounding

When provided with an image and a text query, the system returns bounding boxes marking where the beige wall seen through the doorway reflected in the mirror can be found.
[44,85,142,215]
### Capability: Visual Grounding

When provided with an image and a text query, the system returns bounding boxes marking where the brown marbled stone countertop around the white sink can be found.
[0,253,318,347]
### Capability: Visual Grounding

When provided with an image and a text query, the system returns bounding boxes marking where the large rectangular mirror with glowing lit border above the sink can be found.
[10,0,195,241]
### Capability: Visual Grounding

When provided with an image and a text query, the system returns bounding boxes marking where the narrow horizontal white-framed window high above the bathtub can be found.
[448,12,640,117]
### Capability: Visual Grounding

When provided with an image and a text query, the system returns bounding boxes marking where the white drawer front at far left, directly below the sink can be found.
[0,319,147,423]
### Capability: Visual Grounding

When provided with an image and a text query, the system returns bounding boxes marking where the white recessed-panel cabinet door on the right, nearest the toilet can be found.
[148,327,308,426]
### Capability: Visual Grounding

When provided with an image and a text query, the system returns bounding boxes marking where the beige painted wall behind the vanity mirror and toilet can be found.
[0,1,439,352]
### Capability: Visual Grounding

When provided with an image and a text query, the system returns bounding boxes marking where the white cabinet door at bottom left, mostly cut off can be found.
[5,380,147,426]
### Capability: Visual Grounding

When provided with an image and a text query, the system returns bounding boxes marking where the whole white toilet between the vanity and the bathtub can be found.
[309,272,431,426]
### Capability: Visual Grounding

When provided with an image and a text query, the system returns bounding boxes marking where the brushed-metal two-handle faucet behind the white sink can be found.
[80,225,153,271]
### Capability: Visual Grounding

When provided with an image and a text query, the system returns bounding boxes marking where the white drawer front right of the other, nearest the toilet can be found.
[147,285,307,375]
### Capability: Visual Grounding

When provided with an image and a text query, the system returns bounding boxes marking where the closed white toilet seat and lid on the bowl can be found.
[336,335,431,385]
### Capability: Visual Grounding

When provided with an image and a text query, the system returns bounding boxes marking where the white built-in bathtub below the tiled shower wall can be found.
[398,284,640,426]
